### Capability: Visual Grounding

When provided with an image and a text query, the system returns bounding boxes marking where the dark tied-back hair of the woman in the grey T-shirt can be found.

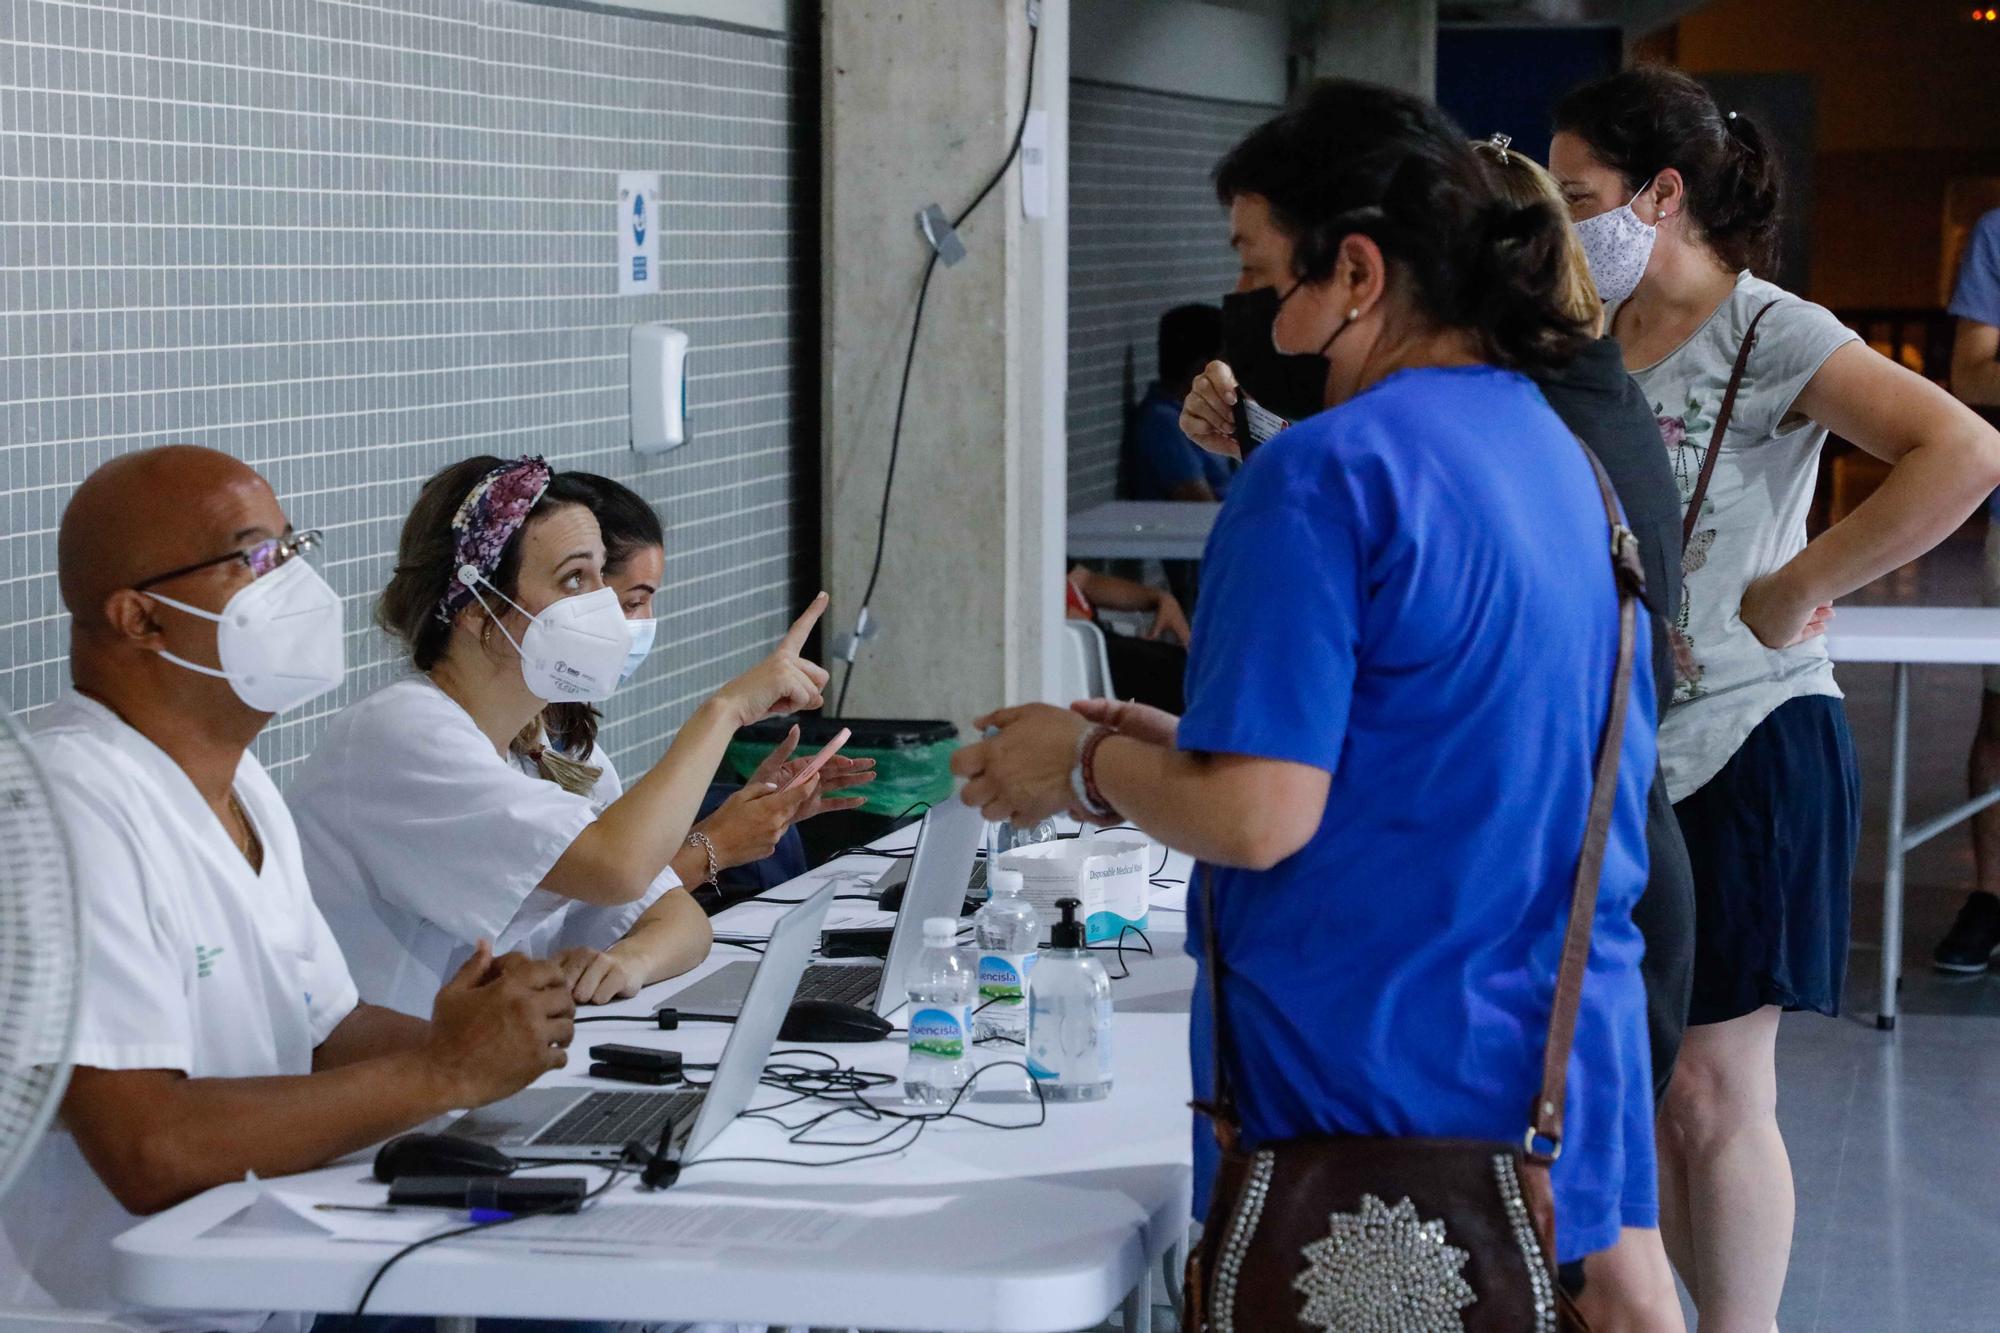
[1556,64,1784,274]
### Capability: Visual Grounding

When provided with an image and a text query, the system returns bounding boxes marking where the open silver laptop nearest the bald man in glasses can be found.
[446,885,834,1161]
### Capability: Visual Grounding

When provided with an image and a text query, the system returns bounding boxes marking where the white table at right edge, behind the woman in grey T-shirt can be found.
[1826,606,2000,1031]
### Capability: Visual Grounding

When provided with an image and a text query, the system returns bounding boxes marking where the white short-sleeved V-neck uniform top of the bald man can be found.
[0,695,356,1329]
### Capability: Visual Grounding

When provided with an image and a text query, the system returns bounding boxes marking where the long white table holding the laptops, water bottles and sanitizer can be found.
[114,836,1192,1333]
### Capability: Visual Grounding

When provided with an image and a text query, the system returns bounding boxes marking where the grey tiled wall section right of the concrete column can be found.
[1068,80,1274,510]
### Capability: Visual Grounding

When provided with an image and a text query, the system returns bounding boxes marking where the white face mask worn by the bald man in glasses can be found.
[144,556,348,713]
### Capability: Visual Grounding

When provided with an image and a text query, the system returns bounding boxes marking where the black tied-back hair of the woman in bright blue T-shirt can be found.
[1216,80,1588,370]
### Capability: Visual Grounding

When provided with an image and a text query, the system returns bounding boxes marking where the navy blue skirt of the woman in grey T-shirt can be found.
[1674,695,1862,1027]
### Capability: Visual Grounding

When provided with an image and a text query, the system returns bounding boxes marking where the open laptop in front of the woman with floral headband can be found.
[666,797,986,1019]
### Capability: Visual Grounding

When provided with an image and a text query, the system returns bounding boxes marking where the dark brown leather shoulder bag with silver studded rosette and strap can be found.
[1186,448,1646,1333]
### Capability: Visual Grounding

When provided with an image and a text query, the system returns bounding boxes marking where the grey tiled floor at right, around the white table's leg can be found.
[1778,532,2000,1333]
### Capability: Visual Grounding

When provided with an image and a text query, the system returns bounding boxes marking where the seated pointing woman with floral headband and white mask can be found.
[290,458,826,1013]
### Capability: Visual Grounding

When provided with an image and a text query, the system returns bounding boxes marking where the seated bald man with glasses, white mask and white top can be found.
[0,446,574,1329]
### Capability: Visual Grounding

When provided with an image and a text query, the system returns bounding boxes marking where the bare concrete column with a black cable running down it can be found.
[820,0,1070,723]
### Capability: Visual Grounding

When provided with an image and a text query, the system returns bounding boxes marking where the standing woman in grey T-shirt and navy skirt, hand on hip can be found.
[1550,66,2000,1333]
